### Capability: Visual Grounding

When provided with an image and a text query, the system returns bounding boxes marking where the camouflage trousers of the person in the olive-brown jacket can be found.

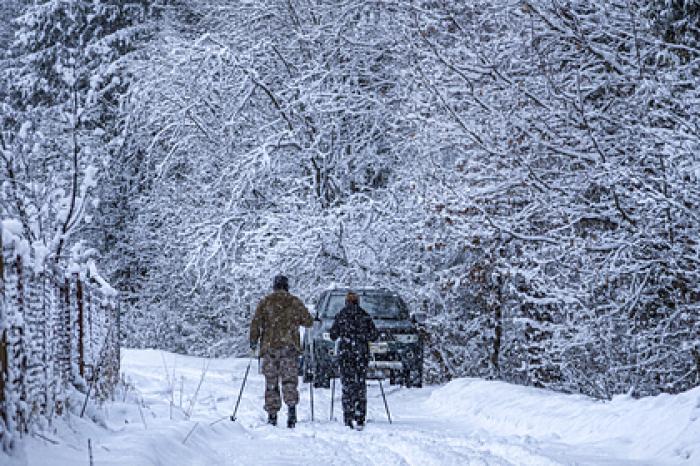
[262,346,299,414]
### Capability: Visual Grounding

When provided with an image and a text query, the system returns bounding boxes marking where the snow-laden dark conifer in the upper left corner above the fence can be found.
[2,0,157,260]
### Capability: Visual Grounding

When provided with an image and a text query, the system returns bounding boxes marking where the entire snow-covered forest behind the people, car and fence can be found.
[0,0,700,398]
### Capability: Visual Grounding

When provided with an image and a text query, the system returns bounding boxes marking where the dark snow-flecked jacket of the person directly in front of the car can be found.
[330,304,379,367]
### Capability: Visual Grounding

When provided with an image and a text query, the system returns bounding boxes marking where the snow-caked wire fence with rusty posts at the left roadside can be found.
[0,234,120,450]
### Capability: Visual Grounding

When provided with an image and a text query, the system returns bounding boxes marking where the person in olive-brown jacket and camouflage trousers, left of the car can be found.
[250,275,313,428]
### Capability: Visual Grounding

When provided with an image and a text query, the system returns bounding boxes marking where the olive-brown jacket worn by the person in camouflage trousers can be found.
[250,291,313,355]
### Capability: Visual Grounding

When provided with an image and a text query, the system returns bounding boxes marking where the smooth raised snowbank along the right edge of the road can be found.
[425,379,700,464]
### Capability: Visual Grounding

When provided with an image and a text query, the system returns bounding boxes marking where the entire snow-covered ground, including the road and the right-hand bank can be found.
[0,350,700,466]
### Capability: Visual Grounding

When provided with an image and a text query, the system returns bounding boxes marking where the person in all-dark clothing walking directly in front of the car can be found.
[330,292,379,429]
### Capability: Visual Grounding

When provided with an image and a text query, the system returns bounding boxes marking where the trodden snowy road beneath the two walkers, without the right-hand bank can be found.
[10,350,690,466]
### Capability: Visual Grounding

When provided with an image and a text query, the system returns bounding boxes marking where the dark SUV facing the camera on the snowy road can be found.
[300,288,425,387]
